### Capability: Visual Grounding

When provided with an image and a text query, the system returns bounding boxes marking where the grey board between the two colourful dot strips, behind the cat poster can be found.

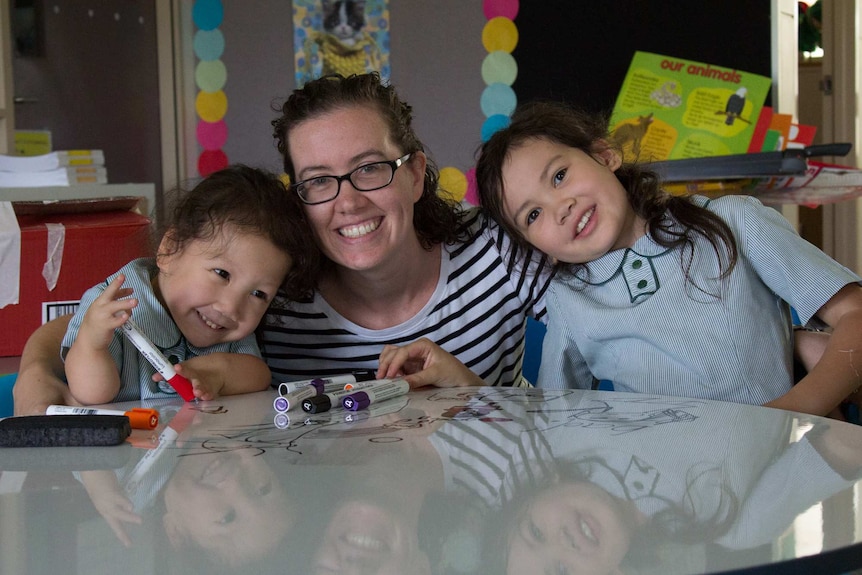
[216,0,487,176]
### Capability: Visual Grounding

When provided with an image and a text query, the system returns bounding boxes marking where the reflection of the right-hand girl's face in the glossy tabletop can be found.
[507,483,637,575]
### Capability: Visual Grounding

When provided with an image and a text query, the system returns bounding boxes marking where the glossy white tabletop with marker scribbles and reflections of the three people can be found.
[0,388,862,575]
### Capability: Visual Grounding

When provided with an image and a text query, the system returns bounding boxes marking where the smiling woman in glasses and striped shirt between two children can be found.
[14,73,549,414]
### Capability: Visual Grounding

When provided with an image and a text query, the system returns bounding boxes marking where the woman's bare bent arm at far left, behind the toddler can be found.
[12,315,80,415]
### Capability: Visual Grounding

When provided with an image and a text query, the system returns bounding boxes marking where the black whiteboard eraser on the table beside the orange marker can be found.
[0,415,132,447]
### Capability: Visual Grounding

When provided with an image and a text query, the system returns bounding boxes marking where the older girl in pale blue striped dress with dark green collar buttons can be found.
[476,102,862,415]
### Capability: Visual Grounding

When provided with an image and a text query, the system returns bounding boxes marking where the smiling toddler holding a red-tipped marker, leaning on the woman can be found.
[62,165,317,405]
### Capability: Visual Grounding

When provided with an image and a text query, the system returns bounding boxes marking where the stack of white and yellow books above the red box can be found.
[0,150,108,188]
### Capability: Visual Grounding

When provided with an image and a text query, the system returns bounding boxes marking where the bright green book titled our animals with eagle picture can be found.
[610,51,772,162]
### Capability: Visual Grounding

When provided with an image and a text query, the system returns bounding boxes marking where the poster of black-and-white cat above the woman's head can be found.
[293,0,390,87]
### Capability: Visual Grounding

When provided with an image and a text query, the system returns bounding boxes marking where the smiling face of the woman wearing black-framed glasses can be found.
[288,106,425,271]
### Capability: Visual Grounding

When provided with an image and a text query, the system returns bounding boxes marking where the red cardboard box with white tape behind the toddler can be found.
[0,211,151,357]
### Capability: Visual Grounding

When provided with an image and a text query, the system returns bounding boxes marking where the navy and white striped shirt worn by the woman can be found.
[262,209,550,386]
